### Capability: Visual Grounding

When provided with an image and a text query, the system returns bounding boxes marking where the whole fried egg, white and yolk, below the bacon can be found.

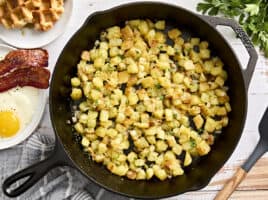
[0,86,39,138]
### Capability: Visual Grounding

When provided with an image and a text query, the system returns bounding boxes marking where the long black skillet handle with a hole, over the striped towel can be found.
[2,141,71,197]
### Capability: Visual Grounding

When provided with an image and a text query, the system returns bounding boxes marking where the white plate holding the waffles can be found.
[0,0,73,49]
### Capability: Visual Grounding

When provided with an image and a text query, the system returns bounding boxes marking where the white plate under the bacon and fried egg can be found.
[0,44,47,149]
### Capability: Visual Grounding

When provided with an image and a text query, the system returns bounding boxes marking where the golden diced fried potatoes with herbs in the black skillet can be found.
[71,20,231,180]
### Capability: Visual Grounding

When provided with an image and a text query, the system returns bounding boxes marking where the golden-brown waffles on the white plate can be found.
[0,0,64,31]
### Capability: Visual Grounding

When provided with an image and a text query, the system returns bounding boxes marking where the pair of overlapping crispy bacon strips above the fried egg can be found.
[0,49,50,92]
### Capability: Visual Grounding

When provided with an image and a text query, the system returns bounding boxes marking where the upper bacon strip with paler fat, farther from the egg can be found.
[0,49,48,75]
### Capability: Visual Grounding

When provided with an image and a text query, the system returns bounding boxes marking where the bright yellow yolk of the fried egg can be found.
[0,111,20,137]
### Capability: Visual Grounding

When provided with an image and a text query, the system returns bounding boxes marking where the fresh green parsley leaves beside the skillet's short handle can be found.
[197,0,268,57]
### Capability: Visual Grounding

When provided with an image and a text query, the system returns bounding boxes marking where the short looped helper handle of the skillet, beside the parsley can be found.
[200,15,258,89]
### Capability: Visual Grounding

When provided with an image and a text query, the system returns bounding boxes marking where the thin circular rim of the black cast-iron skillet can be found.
[49,1,247,199]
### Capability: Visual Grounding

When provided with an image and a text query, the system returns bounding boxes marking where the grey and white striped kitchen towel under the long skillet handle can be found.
[0,132,128,200]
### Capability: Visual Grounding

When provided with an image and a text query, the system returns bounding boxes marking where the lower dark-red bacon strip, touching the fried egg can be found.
[0,66,50,92]
